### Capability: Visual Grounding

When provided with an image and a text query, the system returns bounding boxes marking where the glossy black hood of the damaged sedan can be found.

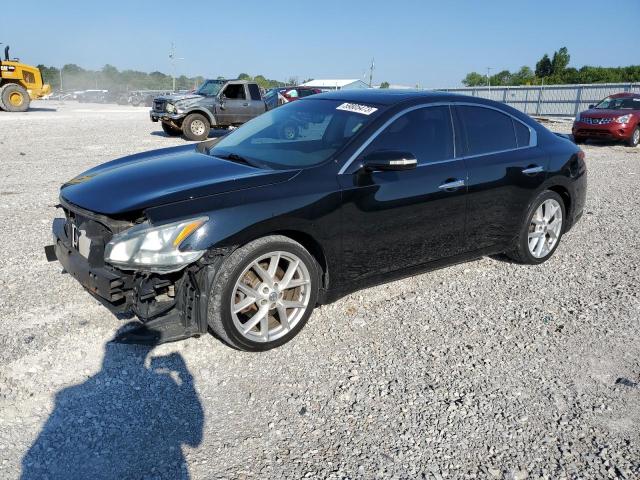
[60,144,298,215]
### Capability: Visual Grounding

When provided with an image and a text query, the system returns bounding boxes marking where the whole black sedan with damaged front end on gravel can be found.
[46,90,587,350]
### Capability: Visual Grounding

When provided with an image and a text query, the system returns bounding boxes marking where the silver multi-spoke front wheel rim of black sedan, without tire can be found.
[230,251,311,343]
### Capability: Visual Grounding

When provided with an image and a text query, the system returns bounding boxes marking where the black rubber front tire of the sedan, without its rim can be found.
[207,235,320,352]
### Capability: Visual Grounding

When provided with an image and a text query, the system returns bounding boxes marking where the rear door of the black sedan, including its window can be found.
[454,104,548,251]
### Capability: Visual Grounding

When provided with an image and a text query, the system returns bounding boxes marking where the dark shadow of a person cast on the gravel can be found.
[21,328,204,480]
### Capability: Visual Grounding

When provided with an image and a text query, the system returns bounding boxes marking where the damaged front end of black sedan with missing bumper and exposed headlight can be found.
[45,201,223,345]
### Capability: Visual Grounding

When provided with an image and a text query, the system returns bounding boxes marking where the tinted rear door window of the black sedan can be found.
[457,106,517,155]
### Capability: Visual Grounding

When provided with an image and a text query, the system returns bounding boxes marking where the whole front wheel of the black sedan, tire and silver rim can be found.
[208,235,319,351]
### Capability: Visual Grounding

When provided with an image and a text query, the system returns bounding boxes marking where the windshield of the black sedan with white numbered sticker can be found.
[210,99,380,169]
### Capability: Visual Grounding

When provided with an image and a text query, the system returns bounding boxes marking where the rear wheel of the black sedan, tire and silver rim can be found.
[507,191,565,265]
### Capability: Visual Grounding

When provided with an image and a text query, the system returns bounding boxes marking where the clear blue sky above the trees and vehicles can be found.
[6,0,640,87]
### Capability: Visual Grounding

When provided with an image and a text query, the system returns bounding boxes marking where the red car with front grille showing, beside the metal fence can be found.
[572,93,640,147]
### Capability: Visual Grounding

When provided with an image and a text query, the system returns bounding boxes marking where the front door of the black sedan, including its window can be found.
[339,106,467,283]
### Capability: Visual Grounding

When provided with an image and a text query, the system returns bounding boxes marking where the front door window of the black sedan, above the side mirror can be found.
[365,107,453,165]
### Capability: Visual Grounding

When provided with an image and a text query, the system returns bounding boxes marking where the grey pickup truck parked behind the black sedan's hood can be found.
[149,79,268,140]
